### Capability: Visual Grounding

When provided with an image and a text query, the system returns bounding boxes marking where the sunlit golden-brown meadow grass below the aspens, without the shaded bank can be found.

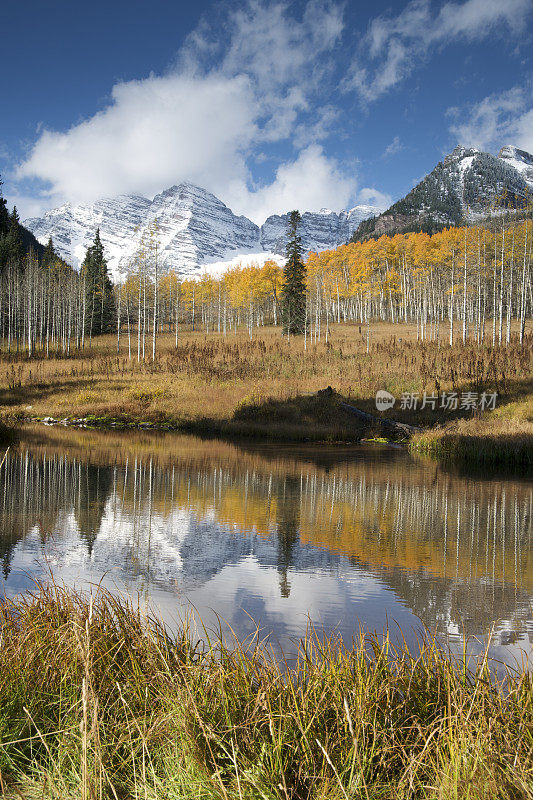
[0,323,533,438]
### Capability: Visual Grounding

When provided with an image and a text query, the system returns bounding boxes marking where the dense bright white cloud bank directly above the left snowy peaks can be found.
[18,73,258,202]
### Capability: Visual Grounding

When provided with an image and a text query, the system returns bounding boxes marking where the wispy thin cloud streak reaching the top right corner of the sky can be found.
[344,0,533,102]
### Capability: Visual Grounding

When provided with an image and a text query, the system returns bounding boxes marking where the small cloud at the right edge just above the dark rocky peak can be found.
[447,86,533,153]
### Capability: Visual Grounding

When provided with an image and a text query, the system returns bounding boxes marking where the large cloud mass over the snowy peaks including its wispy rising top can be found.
[18,0,355,222]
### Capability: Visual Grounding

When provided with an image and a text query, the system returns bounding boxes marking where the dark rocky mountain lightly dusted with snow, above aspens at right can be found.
[356,145,533,240]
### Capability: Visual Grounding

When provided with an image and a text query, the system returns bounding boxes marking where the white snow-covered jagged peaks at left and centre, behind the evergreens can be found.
[24,183,381,277]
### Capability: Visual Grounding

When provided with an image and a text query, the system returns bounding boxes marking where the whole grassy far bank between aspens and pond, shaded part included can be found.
[0,323,533,471]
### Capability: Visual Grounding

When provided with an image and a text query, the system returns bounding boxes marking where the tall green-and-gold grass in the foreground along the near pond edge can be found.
[0,585,533,800]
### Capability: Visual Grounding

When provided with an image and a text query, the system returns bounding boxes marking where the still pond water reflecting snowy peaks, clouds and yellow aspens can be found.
[0,427,533,663]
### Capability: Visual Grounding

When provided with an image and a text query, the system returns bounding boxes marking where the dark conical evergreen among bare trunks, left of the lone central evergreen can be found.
[81,228,116,336]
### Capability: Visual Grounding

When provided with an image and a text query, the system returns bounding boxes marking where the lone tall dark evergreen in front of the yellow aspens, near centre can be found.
[281,211,307,336]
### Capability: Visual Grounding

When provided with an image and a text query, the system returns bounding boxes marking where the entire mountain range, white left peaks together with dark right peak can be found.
[24,145,533,278]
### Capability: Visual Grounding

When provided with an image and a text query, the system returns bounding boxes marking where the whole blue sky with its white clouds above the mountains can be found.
[0,0,533,222]
